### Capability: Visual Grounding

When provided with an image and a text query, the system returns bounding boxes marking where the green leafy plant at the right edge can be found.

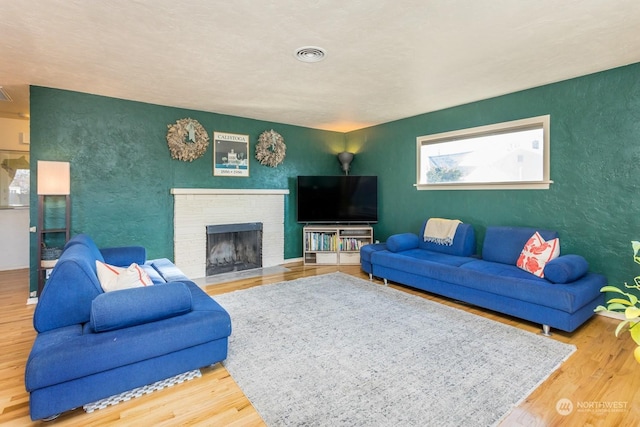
[595,241,640,363]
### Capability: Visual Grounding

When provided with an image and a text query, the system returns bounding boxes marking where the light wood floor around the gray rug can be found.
[0,263,640,426]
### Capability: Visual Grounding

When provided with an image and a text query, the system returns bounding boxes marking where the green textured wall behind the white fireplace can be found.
[30,87,344,290]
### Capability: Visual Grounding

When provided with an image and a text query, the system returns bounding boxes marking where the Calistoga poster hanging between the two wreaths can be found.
[213,132,249,177]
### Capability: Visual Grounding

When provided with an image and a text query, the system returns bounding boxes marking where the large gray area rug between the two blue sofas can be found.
[215,273,575,426]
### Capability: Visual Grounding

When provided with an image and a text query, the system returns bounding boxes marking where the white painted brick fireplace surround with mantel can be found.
[171,188,289,279]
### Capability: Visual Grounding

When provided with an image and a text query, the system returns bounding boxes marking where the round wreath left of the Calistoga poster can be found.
[167,118,209,162]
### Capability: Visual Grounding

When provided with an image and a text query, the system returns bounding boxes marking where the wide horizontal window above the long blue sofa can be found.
[416,115,552,190]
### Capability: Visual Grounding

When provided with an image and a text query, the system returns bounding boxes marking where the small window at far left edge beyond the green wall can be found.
[0,151,30,208]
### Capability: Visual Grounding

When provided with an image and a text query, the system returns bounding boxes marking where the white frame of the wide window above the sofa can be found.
[415,115,553,190]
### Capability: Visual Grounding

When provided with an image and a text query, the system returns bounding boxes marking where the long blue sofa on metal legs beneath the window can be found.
[360,221,606,335]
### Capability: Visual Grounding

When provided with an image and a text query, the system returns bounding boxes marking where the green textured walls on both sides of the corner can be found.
[31,64,640,289]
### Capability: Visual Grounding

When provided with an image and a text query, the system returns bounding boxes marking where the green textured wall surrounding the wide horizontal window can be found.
[347,64,640,284]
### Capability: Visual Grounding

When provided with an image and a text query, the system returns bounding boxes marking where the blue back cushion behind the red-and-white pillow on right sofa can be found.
[482,226,558,265]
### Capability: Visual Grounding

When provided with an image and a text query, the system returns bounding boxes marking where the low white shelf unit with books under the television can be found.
[302,225,373,265]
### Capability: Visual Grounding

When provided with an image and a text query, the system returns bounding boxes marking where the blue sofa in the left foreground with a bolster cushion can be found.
[25,235,231,420]
